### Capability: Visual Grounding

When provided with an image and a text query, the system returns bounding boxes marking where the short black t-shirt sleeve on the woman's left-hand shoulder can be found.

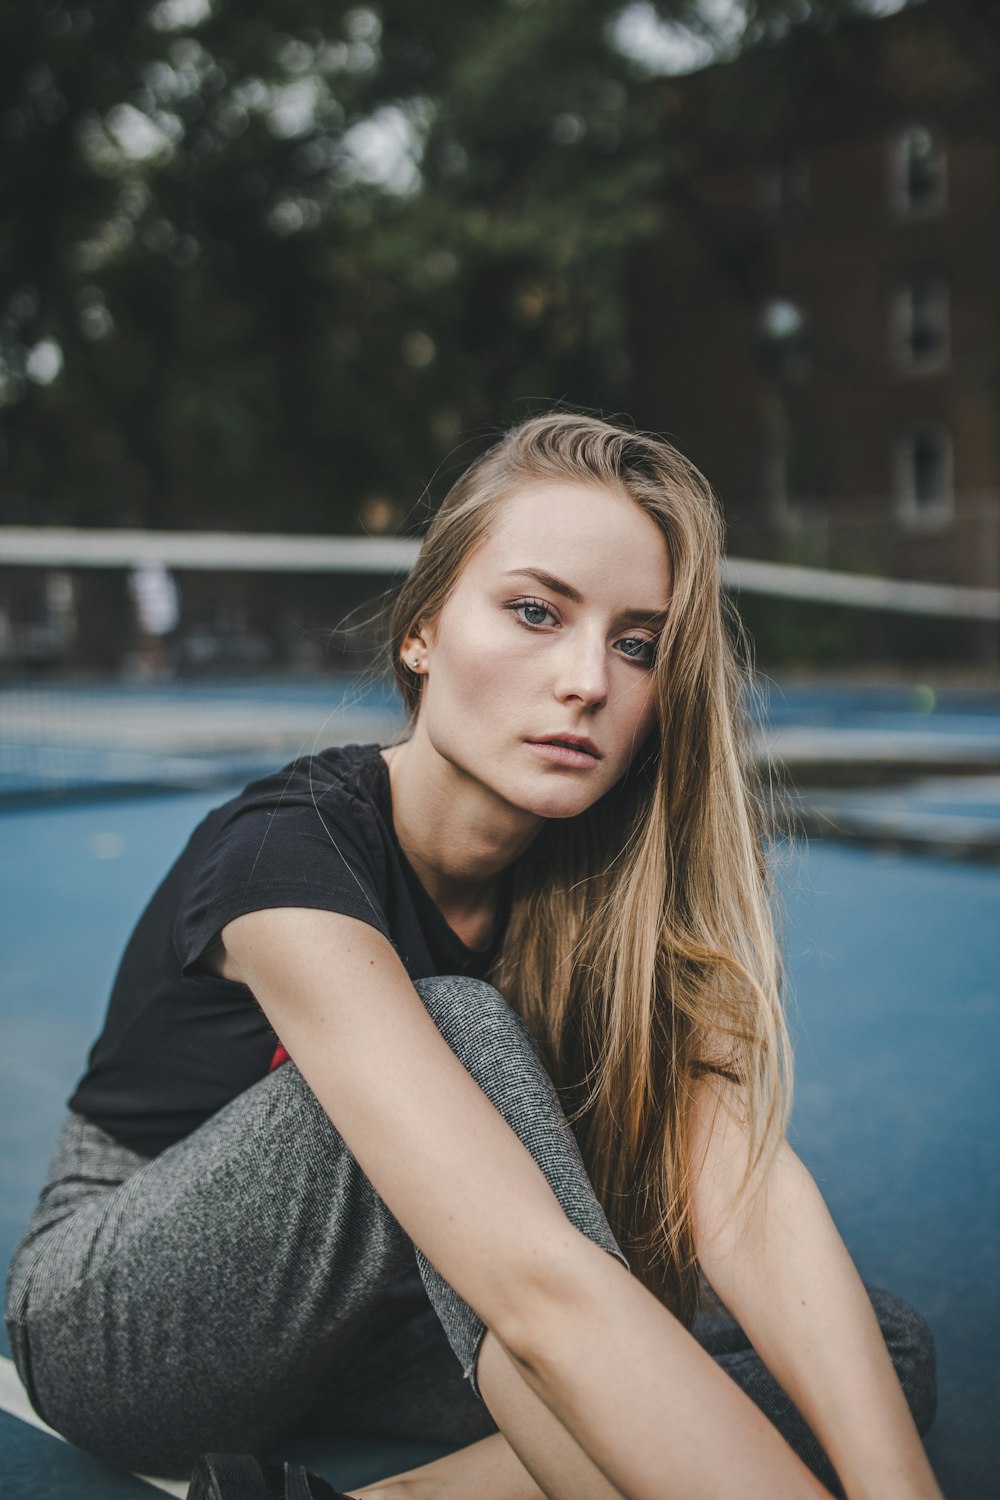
[174,788,390,975]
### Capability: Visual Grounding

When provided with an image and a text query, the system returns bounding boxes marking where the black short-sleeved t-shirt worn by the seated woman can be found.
[69,746,507,1157]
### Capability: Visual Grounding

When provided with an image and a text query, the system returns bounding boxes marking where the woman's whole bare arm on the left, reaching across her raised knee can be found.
[222,909,823,1500]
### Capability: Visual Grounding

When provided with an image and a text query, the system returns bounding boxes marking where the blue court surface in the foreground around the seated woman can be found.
[0,701,1000,1500]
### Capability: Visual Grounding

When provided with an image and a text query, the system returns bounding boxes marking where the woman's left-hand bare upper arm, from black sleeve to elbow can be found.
[222,909,583,1335]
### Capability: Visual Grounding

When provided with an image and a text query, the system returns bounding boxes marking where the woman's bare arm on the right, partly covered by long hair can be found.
[694,1080,940,1500]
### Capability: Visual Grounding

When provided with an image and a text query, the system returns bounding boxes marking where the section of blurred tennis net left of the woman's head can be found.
[0,528,415,801]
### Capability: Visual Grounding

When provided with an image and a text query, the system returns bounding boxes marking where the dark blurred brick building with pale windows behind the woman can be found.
[631,0,1000,585]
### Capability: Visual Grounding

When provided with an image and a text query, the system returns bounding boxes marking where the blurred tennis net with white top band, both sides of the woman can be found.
[0,527,1000,801]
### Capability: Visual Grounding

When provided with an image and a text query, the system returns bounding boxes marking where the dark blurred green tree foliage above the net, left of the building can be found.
[0,0,923,531]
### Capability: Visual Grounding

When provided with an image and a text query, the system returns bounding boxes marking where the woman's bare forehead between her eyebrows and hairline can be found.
[468,483,670,605]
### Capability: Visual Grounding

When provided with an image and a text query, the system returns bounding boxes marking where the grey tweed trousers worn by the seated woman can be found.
[6,977,936,1491]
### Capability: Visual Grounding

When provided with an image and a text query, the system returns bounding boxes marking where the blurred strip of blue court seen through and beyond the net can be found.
[0,677,1000,806]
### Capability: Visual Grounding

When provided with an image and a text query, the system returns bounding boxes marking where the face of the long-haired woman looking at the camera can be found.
[402,483,670,818]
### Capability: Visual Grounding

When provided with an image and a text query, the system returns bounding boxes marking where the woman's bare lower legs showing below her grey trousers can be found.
[349,1332,622,1500]
